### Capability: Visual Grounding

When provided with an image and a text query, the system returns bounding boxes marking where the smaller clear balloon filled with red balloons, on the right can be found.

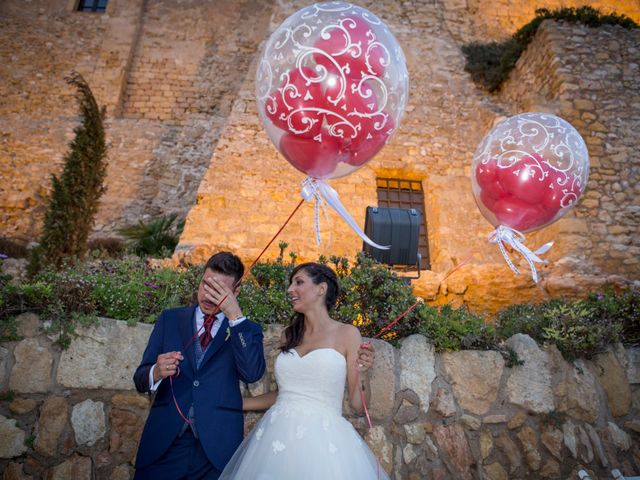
[471,113,589,232]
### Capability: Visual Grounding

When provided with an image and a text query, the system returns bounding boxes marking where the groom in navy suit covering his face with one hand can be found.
[133,252,265,480]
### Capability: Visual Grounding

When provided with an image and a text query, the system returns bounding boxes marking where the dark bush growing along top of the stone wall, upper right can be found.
[462,6,638,92]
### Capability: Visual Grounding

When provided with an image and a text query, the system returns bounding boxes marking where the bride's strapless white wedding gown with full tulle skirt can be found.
[220,348,389,480]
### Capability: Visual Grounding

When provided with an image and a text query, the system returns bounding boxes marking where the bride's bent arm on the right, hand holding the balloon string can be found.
[347,327,374,413]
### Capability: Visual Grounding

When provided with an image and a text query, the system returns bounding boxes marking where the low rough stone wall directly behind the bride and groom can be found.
[0,314,640,480]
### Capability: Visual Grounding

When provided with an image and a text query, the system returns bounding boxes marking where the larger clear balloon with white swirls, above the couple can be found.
[256,2,409,179]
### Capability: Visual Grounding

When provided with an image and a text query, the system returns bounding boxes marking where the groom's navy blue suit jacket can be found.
[133,305,265,471]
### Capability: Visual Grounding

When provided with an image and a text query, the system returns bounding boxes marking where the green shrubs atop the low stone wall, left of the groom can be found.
[0,257,201,348]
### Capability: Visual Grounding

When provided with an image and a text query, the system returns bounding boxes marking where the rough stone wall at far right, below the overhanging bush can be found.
[502,21,640,280]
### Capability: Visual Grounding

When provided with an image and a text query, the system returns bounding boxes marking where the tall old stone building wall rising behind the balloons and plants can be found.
[0,0,640,311]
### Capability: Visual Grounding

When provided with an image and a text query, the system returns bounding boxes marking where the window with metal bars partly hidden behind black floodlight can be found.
[376,178,431,270]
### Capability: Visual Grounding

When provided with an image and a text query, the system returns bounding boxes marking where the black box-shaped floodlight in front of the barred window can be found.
[363,207,420,265]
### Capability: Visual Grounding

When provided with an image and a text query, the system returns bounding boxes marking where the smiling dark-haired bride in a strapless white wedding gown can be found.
[220,263,388,480]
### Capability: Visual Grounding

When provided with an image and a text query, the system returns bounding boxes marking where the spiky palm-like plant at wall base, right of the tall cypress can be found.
[118,213,184,258]
